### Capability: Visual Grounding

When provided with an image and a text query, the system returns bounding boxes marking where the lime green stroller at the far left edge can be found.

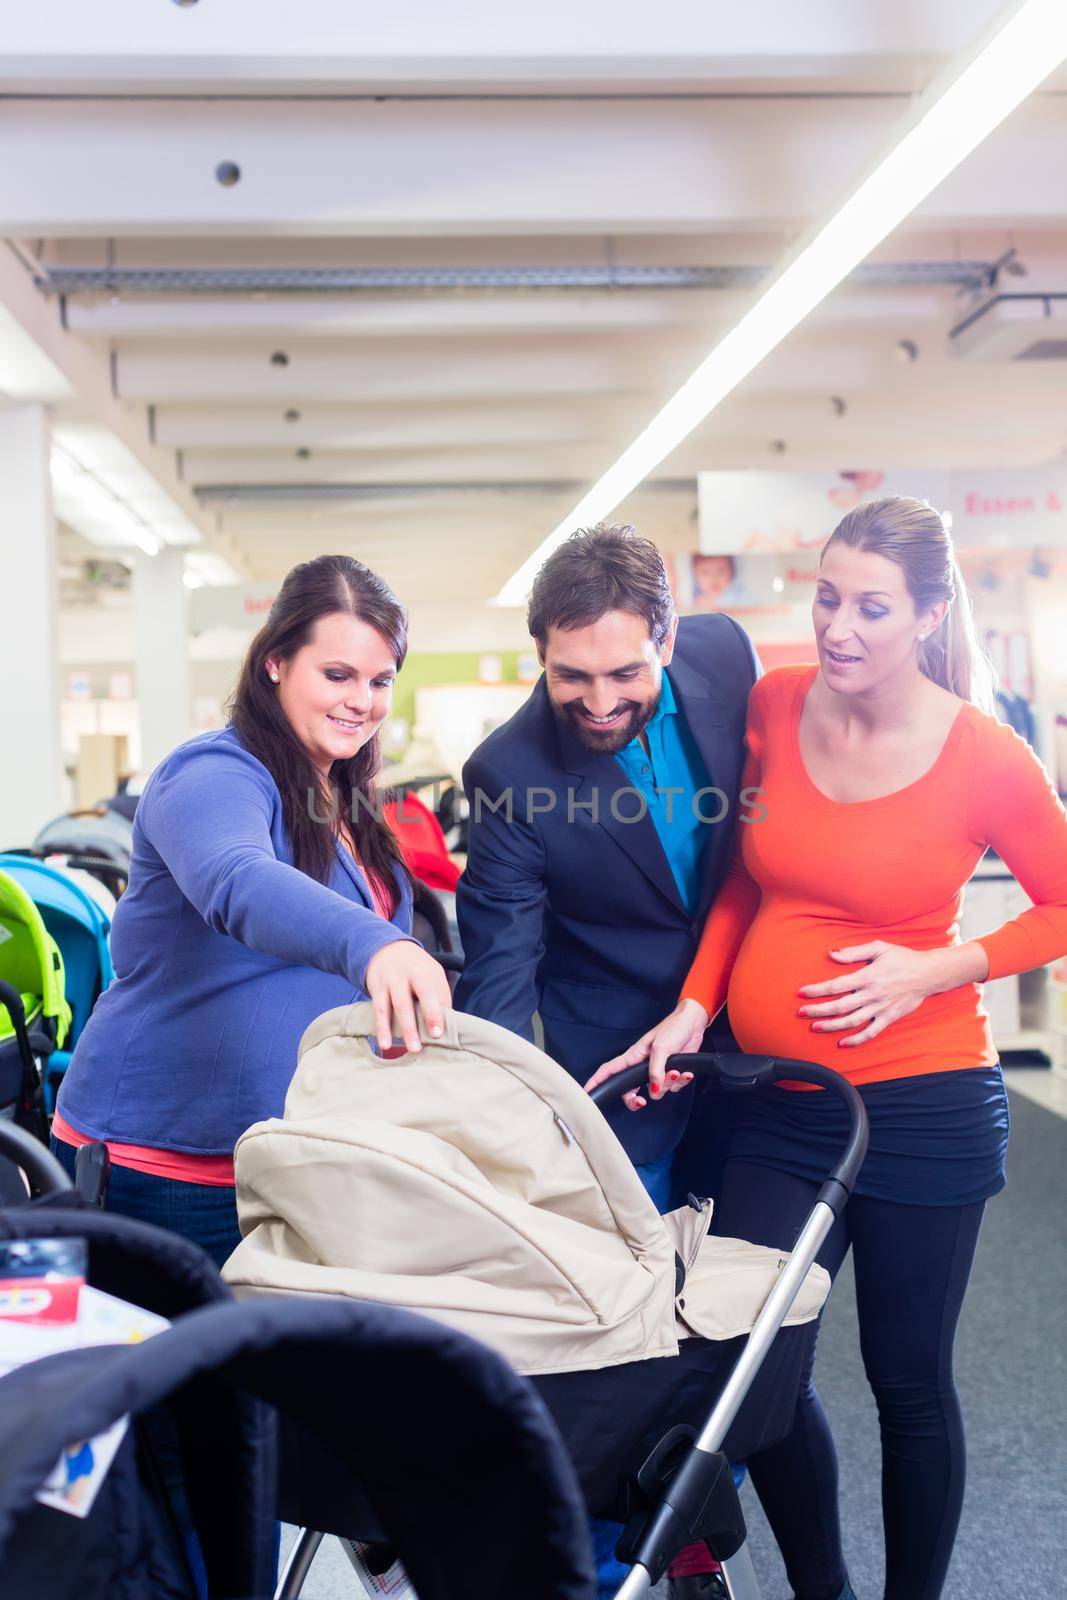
[0,870,70,1138]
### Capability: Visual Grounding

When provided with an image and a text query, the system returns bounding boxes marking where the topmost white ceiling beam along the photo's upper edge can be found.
[0,0,1017,94]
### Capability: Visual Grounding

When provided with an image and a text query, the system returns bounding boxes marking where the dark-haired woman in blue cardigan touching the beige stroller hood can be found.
[53,555,450,1264]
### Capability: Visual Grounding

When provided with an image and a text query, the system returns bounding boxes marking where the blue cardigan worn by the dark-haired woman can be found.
[58,728,411,1155]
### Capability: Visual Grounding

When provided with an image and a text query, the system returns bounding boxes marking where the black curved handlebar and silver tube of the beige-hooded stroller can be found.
[590,1054,867,1600]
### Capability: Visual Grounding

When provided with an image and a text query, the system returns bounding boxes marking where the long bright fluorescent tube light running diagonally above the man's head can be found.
[496,0,1067,605]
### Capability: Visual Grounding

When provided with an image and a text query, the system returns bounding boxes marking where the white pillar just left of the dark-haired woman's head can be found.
[133,547,192,771]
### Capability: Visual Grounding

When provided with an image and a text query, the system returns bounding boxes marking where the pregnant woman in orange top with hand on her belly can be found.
[590,498,1067,1600]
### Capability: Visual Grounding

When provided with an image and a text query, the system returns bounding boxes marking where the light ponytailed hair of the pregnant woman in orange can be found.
[819,494,993,710]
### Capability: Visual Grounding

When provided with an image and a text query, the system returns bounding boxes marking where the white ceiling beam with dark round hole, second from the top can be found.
[0,94,1067,238]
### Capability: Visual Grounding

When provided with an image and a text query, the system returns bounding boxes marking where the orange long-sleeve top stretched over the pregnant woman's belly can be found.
[681,667,1067,1083]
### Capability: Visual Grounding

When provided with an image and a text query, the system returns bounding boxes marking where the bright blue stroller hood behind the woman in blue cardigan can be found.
[0,854,115,1112]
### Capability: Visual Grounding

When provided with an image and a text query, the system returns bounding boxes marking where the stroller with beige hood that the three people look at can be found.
[224,1005,867,1600]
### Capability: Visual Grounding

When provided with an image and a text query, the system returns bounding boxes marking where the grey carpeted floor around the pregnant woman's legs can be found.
[279,1094,1067,1600]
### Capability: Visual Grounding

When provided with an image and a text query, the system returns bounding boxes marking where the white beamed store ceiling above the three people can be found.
[0,0,1067,603]
